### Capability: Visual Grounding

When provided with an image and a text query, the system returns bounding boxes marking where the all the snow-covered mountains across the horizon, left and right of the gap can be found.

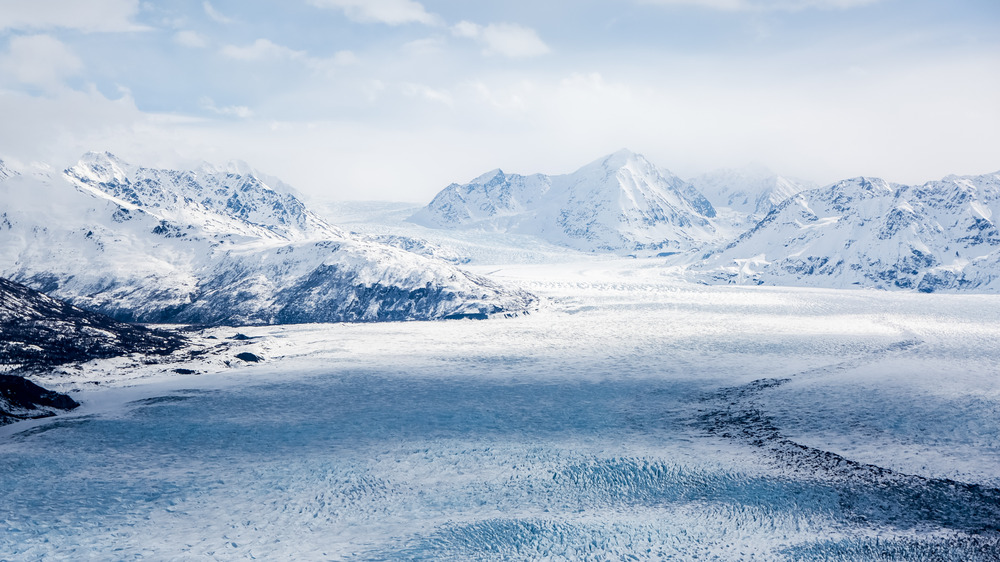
[7,150,1000,302]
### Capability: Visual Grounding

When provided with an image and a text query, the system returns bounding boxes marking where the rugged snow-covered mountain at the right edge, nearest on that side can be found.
[695,172,1000,292]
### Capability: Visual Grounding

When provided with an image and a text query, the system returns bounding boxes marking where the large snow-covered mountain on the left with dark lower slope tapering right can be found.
[0,153,535,324]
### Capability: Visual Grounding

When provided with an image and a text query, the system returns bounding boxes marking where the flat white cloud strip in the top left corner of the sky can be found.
[0,0,148,32]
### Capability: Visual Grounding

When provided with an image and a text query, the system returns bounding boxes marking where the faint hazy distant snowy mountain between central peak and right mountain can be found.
[690,165,818,228]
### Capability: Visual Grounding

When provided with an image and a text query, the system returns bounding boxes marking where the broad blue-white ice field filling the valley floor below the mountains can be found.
[0,260,1000,560]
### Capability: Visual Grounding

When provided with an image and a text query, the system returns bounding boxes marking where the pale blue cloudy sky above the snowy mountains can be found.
[0,0,1000,202]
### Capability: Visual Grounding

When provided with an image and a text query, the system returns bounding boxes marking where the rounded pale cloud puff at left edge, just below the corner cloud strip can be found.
[0,35,83,90]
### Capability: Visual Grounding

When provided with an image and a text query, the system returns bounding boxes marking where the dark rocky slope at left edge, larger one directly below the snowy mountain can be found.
[0,278,185,367]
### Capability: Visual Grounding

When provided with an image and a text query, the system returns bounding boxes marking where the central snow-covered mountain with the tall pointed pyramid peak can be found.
[410,150,721,254]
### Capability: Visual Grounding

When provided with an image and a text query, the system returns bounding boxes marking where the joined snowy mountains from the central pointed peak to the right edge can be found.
[410,150,1000,292]
